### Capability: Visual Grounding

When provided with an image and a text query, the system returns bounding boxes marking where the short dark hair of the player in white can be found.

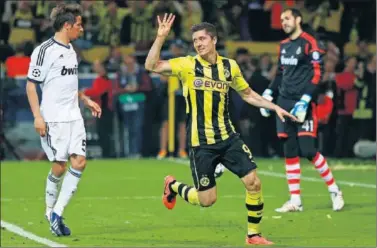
[50,3,82,31]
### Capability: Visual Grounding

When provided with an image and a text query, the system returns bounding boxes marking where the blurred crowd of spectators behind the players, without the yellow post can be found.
[0,0,376,158]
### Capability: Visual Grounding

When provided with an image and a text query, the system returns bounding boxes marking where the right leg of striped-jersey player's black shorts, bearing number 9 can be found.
[221,136,257,178]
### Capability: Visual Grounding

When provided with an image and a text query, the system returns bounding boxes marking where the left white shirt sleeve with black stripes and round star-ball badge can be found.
[27,46,51,84]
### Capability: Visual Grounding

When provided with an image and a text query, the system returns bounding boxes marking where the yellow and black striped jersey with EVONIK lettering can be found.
[169,55,249,147]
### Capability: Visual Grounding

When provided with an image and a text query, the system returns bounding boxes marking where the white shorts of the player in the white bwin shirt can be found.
[41,120,86,162]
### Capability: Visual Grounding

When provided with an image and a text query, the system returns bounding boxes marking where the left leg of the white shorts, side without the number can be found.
[41,122,70,162]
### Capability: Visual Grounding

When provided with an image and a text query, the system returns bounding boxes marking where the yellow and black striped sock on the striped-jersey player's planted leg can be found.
[246,191,263,235]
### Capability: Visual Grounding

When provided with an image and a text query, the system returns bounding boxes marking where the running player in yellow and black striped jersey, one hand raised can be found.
[145,14,297,245]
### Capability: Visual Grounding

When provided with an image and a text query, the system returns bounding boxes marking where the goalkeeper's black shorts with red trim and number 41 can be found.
[276,97,318,138]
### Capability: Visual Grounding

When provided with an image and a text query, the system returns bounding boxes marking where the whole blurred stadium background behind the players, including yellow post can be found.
[0,0,376,160]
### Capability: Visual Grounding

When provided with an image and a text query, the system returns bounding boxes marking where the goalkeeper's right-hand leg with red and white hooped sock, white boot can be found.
[298,136,344,211]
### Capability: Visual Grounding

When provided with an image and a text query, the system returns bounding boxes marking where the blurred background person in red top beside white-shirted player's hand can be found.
[84,61,115,158]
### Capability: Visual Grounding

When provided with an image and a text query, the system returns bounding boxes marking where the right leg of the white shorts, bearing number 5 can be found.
[68,120,86,157]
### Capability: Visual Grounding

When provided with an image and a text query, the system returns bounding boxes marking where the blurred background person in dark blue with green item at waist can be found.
[117,55,152,158]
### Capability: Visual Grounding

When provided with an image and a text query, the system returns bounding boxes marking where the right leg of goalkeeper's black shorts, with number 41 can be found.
[296,103,318,138]
